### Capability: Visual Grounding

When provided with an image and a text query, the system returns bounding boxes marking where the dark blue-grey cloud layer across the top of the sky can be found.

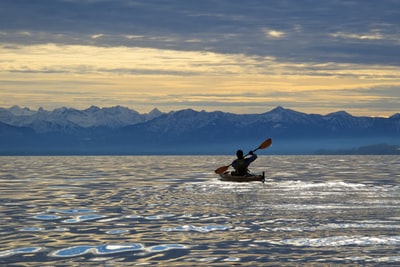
[0,0,400,64]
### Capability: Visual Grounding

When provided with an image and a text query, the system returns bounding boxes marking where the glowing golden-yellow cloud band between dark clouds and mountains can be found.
[0,43,400,115]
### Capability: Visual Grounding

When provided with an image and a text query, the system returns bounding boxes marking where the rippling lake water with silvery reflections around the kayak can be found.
[0,156,400,266]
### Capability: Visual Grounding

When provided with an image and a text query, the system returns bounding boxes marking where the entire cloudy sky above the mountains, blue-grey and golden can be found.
[0,0,400,116]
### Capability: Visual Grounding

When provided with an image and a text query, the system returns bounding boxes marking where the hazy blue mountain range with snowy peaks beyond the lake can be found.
[0,106,400,155]
